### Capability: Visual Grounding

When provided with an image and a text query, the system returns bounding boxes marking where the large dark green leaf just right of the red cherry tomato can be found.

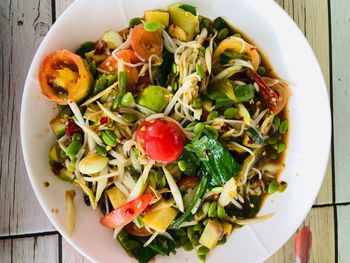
[185,132,240,185]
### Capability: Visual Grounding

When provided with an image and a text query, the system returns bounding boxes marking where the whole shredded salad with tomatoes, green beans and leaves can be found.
[39,3,290,262]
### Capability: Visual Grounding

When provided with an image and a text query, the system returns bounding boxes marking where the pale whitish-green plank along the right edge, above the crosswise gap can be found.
[331,0,350,202]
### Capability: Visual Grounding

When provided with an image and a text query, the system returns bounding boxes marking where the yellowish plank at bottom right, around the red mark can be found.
[265,207,334,263]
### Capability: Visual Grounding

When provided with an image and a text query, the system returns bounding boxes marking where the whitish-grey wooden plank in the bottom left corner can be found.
[0,235,58,263]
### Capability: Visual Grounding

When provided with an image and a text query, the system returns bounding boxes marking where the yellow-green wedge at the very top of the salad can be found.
[168,4,199,41]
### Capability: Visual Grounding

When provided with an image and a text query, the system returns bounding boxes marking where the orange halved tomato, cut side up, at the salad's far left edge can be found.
[39,49,93,105]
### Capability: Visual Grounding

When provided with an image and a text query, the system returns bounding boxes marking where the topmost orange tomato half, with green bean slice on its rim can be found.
[130,24,163,60]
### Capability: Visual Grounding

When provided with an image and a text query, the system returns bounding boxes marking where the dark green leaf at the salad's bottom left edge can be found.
[117,230,158,263]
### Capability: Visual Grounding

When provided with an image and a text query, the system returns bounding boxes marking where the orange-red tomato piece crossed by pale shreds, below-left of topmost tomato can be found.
[99,49,140,91]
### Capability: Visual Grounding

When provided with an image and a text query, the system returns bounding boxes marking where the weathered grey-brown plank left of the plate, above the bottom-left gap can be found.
[0,0,54,235]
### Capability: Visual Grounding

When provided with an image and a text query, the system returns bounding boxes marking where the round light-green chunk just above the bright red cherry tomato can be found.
[137,86,171,112]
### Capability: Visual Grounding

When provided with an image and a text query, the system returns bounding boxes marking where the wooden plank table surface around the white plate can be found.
[0,0,350,263]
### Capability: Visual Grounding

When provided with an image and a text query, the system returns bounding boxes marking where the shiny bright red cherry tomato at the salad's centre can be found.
[136,119,186,163]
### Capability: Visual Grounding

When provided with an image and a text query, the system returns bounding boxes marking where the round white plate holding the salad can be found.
[21,0,331,263]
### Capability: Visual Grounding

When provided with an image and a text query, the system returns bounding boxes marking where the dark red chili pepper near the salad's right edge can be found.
[247,70,278,111]
